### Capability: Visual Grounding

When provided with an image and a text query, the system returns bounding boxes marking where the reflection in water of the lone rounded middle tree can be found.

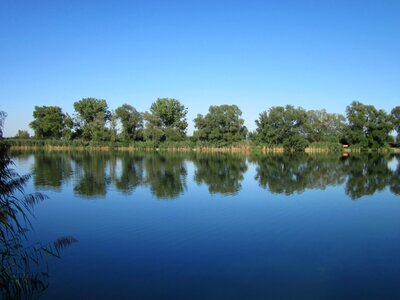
[193,153,247,194]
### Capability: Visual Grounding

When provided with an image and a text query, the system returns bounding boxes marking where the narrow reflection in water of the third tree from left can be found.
[110,152,144,193]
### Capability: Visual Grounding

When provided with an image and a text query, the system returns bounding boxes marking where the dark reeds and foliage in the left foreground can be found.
[0,112,75,299]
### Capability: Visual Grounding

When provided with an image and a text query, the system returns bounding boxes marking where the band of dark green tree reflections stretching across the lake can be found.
[17,152,400,199]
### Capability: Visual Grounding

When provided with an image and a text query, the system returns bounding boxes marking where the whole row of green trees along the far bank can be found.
[16,98,400,151]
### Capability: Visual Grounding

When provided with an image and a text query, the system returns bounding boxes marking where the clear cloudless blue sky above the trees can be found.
[0,0,400,136]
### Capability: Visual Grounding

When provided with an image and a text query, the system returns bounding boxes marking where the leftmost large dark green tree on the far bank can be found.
[30,106,65,139]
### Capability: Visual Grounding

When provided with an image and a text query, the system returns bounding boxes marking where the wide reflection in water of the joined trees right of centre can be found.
[252,153,344,195]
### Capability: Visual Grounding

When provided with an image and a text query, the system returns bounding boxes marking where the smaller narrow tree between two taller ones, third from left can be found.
[115,104,143,142]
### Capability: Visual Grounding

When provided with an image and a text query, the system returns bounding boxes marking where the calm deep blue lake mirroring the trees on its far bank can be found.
[8,152,400,299]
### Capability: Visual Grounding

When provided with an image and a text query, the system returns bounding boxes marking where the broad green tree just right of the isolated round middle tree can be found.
[255,105,309,151]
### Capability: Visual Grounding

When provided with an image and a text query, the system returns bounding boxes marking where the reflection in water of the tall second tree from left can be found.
[72,152,111,196]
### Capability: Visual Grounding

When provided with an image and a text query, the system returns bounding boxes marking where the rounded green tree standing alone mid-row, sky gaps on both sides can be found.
[193,105,247,145]
